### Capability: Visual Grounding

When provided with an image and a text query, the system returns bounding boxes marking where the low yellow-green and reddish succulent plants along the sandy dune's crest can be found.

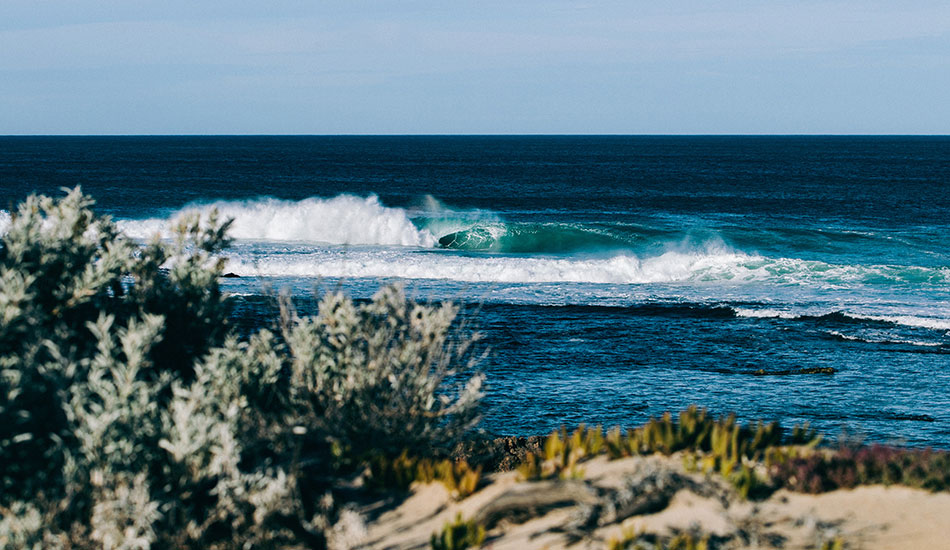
[518,406,950,498]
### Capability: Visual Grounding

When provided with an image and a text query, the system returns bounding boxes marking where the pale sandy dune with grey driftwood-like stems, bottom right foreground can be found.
[354,456,950,550]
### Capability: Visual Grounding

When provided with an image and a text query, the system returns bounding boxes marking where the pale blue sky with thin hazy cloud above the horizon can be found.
[0,0,950,134]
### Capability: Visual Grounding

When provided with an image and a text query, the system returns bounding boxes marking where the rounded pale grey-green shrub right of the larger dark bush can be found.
[283,286,483,459]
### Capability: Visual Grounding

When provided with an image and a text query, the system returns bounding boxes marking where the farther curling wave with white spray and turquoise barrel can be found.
[117,195,649,254]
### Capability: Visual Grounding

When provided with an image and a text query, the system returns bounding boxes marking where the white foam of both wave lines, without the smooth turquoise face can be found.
[106,195,950,285]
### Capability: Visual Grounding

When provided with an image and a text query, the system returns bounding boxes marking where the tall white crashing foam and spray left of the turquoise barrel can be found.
[118,195,436,247]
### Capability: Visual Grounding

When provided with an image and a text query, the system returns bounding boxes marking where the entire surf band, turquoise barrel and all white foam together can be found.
[91,194,950,347]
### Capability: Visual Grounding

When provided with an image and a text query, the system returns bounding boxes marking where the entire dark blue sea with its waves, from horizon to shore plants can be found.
[0,136,950,447]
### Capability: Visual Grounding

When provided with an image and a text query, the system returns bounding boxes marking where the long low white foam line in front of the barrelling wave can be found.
[216,231,950,294]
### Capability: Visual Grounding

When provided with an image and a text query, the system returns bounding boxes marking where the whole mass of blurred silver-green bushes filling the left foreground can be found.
[0,190,481,549]
